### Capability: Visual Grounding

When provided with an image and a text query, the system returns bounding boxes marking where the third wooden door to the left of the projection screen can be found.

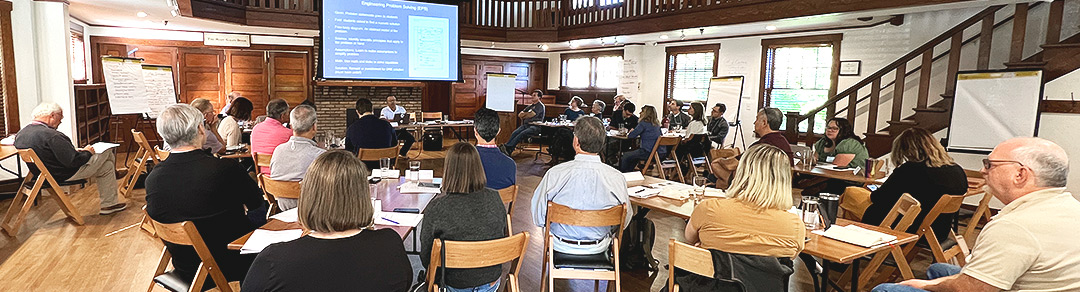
[179,49,225,110]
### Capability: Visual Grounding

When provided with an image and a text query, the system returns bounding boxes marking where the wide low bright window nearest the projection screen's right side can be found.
[562,51,622,90]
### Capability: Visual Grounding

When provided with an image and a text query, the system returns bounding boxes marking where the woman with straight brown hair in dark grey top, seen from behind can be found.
[420,143,508,292]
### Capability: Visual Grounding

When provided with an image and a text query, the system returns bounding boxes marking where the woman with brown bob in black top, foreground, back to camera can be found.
[243,150,413,291]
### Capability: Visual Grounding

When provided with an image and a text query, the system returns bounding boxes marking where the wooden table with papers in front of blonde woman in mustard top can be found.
[626,176,918,291]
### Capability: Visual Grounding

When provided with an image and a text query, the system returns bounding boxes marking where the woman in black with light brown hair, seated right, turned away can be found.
[863,128,968,240]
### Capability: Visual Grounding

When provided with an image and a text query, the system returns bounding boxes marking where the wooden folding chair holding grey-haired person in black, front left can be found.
[147,218,233,292]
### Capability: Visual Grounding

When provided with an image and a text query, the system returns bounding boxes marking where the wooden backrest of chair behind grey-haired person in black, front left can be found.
[147,216,232,292]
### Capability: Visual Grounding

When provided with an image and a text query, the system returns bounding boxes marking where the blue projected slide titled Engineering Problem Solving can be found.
[320,0,460,81]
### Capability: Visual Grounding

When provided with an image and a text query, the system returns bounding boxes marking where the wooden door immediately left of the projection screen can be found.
[270,52,311,108]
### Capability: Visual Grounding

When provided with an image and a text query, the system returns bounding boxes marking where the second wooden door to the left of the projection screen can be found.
[222,50,270,119]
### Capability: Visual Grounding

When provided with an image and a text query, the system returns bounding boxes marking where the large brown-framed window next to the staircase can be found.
[761,35,840,133]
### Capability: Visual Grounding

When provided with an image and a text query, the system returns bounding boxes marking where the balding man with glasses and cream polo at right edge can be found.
[874,137,1080,292]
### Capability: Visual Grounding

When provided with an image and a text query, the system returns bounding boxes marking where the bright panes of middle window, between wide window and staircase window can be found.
[664,44,720,103]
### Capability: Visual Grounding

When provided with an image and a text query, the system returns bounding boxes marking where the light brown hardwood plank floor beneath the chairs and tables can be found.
[0,140,937,291]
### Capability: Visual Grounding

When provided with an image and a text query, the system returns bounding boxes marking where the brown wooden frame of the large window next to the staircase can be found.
[757,34,843,133]
